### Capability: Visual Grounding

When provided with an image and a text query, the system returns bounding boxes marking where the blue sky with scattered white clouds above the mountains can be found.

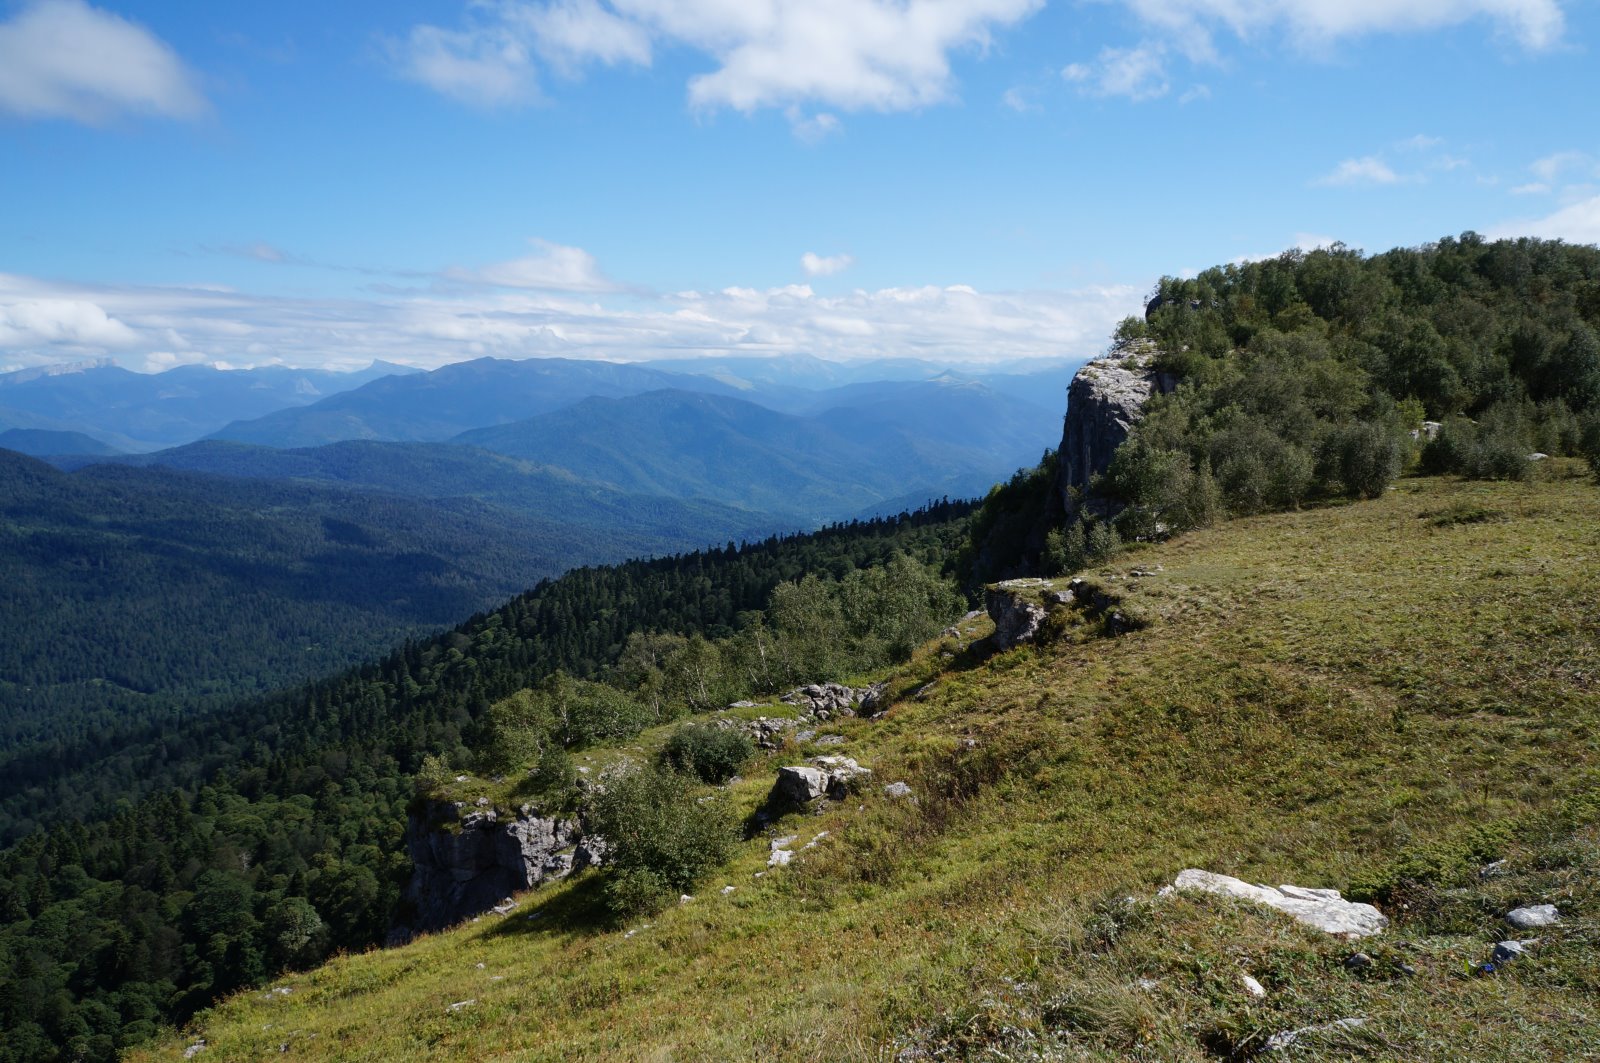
[0,0,1600,371]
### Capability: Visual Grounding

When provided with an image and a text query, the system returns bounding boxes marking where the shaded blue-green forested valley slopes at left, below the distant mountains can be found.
[0,445,771,840]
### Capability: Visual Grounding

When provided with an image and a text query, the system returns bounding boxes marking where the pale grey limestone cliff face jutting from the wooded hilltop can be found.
[1059,339,1176,515]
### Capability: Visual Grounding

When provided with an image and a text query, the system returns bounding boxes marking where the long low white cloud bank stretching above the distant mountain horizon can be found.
[0,274,1141,368]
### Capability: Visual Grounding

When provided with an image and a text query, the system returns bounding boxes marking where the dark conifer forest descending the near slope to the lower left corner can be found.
[0,503,970,1061]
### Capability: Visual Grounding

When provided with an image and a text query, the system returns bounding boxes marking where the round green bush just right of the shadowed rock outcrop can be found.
[584,765,736,916]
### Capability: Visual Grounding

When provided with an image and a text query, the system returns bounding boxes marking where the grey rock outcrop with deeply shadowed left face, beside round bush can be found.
[406,802,605,930]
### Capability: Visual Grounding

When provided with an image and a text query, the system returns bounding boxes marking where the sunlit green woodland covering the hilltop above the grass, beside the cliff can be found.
[973,232,1600,575]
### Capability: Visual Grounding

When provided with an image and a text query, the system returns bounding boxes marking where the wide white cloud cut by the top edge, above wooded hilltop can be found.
[1122,0,1565,53]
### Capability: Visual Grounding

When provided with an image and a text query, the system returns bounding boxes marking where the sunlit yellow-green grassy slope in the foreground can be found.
[133,466,1600,1060]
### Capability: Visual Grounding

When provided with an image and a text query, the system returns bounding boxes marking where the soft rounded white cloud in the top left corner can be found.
[0,0,206,125]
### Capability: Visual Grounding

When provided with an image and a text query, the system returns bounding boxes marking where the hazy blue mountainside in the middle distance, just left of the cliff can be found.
[453,383,1059,522]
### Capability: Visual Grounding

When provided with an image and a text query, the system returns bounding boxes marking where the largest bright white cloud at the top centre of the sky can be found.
[394,0,1043,112]
